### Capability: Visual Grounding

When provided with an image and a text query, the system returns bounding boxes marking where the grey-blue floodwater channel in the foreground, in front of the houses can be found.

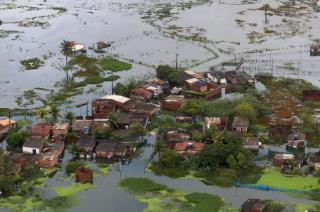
[1,135,318,212]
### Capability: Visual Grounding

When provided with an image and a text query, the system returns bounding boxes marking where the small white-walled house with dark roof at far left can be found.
[22,136,44,155]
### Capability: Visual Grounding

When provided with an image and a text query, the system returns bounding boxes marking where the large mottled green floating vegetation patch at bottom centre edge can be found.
[119,178,225,212]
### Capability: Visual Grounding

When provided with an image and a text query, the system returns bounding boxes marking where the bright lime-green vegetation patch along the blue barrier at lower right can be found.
[257,168,320,190]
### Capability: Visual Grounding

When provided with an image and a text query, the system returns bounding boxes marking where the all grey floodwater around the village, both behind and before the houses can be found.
[0,0,320,212]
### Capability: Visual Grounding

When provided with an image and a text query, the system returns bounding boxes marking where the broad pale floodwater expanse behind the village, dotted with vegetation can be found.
[0,0,320,108]
